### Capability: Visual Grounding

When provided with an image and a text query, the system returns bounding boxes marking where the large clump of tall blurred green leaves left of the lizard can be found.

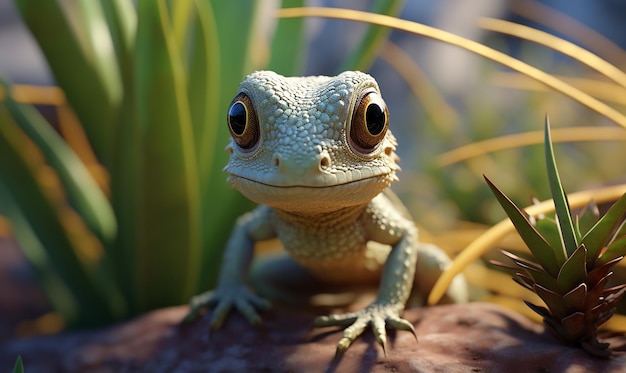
[0,0,399,327]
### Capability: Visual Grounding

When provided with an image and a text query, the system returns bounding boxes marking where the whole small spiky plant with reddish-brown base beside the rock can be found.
[485,117,626,357]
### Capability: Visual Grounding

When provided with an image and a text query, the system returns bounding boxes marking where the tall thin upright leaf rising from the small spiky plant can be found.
[544,115,578,256]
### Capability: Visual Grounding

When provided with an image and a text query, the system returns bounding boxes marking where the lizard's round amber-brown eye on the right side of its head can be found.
[350,92,389,153]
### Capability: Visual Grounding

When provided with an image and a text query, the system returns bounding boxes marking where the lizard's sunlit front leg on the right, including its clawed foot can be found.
[314,219,419,356]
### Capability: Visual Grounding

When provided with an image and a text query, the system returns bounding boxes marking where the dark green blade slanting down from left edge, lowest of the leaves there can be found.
[0,105,119,326]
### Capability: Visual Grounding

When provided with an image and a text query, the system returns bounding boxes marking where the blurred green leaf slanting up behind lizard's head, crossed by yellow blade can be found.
[339,0,405,72]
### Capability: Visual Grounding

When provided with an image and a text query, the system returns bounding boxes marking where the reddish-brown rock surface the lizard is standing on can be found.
[0,303,626,373]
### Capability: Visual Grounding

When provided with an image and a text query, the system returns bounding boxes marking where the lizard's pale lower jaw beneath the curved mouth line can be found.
[228,173,396,212]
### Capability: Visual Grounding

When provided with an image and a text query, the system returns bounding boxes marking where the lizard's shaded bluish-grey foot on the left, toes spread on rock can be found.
[184,285,270,329]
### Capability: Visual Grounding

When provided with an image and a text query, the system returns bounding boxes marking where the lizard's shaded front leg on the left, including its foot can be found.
[185,206,275,329]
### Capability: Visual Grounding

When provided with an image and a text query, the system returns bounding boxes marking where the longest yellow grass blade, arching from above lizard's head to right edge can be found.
[278,7,626,128]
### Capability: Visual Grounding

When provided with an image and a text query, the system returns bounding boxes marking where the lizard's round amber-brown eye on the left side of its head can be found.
[228,92,259,149]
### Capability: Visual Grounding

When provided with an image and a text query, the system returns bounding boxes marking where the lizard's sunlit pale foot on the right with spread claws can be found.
[314,303,417,358]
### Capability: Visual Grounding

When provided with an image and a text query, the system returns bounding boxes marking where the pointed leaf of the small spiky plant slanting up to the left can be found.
[484,176,560,277]
